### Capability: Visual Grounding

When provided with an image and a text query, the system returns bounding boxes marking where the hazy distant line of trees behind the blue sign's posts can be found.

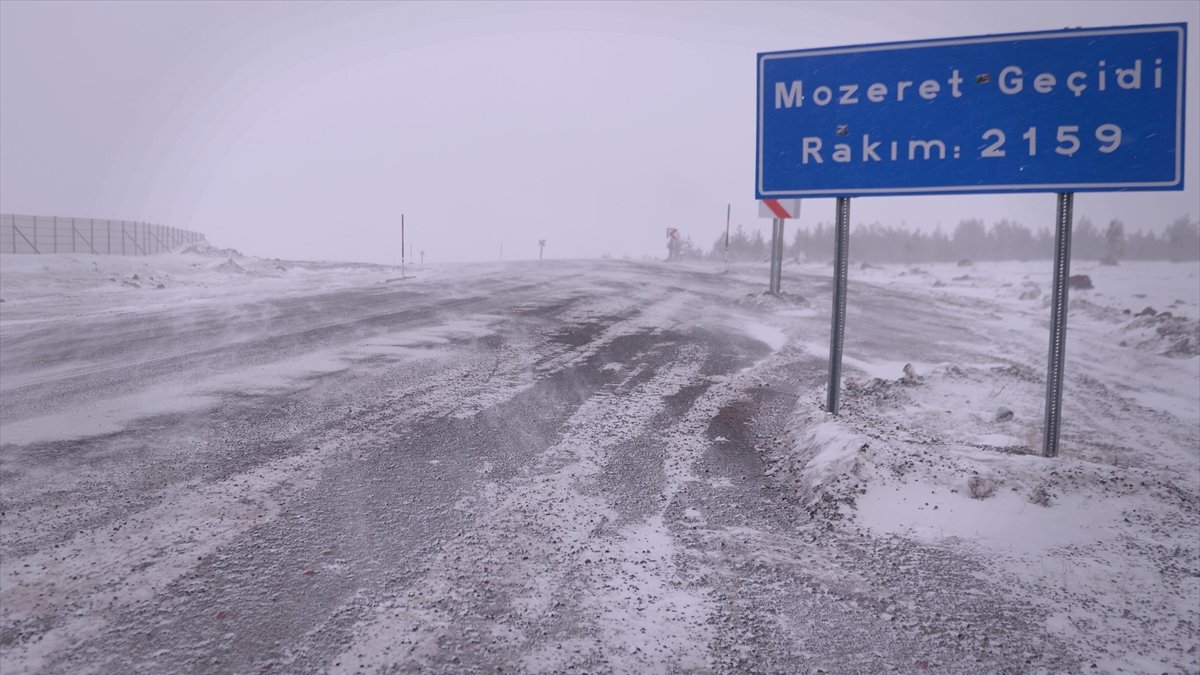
[678,216,1200,263]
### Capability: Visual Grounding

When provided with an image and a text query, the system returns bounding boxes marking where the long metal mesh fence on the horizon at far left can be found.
[0,214,204,256]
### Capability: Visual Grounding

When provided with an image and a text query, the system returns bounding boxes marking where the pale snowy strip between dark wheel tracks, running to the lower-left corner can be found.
[0,321,552,673]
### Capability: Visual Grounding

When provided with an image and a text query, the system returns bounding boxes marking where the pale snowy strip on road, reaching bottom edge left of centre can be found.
[332,343,704,673]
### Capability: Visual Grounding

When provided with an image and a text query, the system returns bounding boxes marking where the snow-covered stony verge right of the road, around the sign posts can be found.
[770,255,1200,673]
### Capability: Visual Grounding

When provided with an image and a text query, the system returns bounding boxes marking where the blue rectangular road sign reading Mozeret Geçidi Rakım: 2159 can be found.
[755,23,1187,199]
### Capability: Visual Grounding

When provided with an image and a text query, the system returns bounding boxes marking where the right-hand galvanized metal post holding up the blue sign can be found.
[1042,192,1075,458]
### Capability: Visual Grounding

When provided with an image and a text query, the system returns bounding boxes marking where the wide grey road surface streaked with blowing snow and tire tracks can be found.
[0,261,1171,674]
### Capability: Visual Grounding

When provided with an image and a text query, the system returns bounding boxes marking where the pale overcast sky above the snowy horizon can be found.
[0,0,1200,263]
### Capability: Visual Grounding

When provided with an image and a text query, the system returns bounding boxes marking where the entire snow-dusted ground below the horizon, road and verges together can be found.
[0,256,1200,674]
